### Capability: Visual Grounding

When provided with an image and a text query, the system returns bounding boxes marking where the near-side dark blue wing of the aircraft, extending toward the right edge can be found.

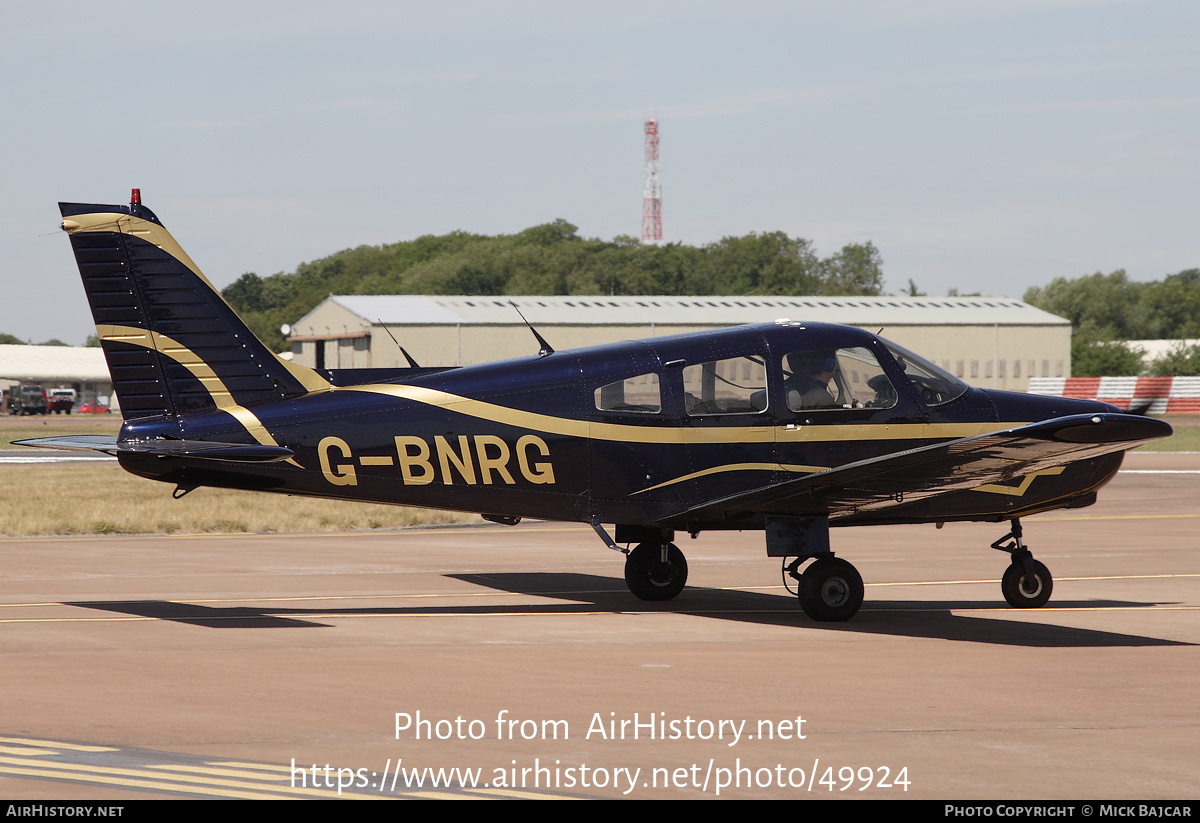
[685,414,1171,518]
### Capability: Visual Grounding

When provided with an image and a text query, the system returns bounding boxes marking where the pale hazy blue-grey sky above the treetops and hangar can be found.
[0,0,1200,344]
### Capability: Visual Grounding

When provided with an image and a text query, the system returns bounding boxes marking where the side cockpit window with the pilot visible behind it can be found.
[782,346,896,412]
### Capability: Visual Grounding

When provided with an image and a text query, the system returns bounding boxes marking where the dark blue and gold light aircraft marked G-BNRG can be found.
[25,190,1171,620]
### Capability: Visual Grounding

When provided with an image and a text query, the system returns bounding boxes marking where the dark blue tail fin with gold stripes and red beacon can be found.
[59,195,329,420]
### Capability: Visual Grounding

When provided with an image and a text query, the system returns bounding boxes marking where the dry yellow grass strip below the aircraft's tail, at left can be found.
[0,463,479,536]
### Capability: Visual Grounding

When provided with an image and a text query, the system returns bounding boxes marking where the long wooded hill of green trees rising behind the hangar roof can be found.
[222,220,883,350]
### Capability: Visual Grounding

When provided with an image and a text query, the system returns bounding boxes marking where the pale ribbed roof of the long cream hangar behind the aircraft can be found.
[304,294,1070,334]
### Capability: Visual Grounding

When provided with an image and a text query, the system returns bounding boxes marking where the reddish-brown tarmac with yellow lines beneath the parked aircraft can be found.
[0,453,1200,800]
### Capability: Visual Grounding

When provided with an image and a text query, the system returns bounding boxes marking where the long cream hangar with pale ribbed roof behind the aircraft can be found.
[288,295,1070,391]
